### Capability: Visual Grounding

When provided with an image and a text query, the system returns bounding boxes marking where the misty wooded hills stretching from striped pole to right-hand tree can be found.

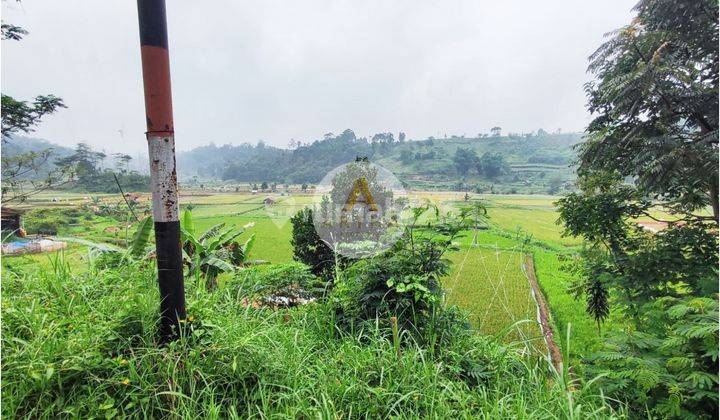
[178,130,582,193]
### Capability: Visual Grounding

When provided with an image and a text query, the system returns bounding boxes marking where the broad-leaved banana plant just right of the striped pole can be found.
[180,210,255,290]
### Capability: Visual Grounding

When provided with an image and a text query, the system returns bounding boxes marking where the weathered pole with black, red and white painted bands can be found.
[138,0,185,340]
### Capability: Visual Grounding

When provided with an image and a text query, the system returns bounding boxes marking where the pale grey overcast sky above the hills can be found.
[2,0,635,153]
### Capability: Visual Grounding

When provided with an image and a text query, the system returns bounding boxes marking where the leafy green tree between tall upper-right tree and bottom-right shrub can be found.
[558,177,717,320]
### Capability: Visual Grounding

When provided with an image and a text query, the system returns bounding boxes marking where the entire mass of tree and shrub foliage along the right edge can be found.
[558,0,718,418]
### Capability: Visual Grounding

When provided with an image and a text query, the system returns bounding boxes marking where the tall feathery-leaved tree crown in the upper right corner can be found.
[579,0,718,221]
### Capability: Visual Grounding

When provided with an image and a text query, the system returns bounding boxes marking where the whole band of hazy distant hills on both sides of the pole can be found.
[3,129,581,193]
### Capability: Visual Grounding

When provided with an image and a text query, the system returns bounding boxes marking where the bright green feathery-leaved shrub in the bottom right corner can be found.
[588,296,718,419]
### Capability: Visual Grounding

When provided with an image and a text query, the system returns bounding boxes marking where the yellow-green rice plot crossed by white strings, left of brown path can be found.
[443,248,547,354]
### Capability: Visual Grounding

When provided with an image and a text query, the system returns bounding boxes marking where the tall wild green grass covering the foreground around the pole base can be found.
[2,256,622,418]
